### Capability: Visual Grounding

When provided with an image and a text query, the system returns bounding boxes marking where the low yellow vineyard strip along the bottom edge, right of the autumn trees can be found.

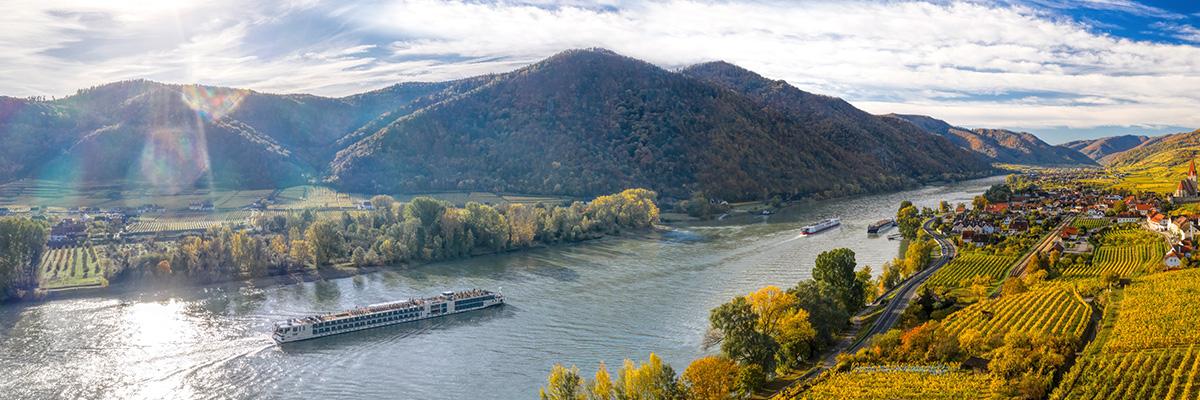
[794,365,991,400]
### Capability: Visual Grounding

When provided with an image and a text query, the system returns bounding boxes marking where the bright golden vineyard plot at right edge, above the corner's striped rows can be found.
[1105,269,1200,351]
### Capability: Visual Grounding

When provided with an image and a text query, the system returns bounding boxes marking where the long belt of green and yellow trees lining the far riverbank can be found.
[0,189,659,300]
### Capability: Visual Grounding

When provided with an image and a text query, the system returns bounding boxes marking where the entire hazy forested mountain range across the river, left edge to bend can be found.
[0,49,991,199]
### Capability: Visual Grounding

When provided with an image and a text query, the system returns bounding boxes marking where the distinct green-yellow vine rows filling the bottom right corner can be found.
[1051,345,1200,399]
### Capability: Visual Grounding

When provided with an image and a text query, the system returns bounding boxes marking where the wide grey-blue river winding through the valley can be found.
[0,177,1001,399]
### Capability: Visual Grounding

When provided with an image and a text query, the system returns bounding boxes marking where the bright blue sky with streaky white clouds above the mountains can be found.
[0,0,1200,143]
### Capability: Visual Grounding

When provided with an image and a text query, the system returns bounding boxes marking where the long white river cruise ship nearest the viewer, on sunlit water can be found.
[271,289,504,344]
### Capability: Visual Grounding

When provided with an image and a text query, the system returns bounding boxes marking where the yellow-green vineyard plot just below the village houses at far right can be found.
[1063,228,1166,279]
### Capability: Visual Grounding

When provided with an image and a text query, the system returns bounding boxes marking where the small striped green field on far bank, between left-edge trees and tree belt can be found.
[37,246,112,288]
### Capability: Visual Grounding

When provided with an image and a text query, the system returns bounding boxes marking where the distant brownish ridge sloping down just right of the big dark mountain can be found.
[884,114,1096,166]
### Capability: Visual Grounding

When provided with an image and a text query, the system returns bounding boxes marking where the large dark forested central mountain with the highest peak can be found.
[331,50,990,199]
